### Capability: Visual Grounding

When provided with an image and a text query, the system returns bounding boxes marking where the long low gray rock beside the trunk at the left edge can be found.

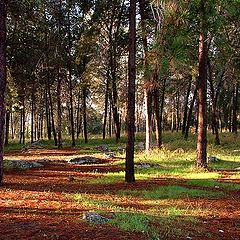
[3,160,43,170]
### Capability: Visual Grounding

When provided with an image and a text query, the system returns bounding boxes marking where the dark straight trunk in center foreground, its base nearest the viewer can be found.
[125,0,136,183]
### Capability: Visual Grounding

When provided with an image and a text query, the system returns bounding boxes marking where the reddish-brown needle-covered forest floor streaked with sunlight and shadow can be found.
[0,148,240,240]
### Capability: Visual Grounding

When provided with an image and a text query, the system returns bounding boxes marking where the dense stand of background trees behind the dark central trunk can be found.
[0,0,240,172]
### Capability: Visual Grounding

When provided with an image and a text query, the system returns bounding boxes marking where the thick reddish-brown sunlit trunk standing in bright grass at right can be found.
[196,0,207,168]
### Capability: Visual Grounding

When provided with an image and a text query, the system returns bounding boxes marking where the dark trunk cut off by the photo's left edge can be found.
[0,0,7,185]
